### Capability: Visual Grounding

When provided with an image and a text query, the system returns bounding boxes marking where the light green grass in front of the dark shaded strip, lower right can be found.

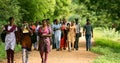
[92,46,120,63]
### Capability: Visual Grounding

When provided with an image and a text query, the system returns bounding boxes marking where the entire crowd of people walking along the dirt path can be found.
[3,17,93,63]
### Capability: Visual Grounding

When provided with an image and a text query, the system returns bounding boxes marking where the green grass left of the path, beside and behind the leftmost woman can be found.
[0,42,21,60]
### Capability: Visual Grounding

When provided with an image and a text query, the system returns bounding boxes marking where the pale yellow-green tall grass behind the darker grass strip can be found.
[94,27,120,41]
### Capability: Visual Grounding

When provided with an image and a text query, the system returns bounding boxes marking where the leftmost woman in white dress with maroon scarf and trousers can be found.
[4,17,17,63]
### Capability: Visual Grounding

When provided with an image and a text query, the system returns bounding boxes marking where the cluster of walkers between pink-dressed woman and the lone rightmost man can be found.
[52,19,80,51]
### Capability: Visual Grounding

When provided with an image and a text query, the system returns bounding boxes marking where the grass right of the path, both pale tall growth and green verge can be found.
[91,28,120,63]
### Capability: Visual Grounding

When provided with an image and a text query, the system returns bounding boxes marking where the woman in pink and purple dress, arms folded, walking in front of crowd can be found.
[38,20,52,63]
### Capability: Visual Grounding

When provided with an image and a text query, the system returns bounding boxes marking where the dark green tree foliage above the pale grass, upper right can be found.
[72,0,120,30]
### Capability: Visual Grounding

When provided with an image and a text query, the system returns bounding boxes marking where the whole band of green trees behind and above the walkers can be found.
[0,0,120,29]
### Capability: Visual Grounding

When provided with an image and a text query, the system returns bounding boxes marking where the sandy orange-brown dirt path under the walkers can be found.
[0,37,98,63]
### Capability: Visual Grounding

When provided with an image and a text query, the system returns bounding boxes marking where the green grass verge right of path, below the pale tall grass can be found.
[91,39,120,63]
